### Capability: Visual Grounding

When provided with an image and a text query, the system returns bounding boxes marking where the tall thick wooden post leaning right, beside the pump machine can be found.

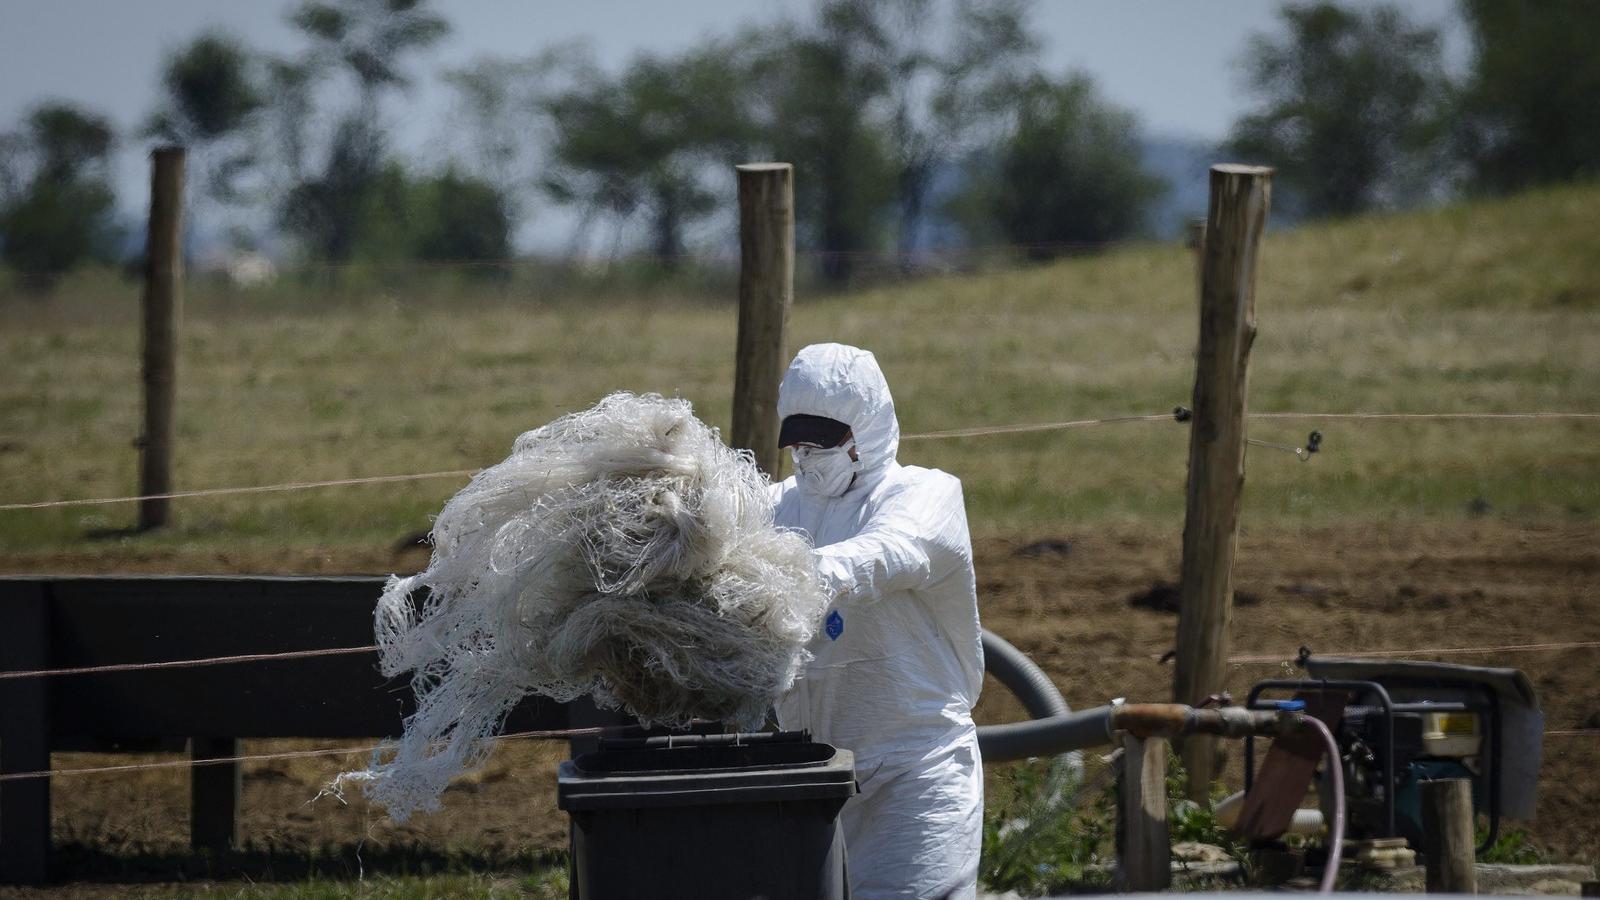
[1173,165,1272,804]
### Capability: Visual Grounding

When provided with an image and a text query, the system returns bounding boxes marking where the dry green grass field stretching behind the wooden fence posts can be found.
[0,180,1600,569]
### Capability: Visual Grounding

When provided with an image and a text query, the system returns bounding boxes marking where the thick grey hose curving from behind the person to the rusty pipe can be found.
[978,629,1110,777]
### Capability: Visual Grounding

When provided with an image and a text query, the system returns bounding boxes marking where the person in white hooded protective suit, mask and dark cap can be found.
[773,344,984,900]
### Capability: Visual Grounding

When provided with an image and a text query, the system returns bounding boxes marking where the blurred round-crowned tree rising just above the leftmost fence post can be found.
[144,32,266,235]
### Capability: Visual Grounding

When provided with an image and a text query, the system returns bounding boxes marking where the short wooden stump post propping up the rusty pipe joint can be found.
[1117,735,1173,894]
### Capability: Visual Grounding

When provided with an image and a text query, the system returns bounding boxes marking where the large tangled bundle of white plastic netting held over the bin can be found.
[339,392,826,820]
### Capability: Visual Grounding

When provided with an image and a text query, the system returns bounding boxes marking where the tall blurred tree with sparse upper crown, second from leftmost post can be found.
[275,0,450,261]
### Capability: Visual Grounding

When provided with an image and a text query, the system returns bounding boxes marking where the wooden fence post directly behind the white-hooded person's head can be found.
[730,163,795,477]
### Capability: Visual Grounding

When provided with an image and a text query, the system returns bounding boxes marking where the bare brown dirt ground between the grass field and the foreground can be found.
[25,520,1600,879]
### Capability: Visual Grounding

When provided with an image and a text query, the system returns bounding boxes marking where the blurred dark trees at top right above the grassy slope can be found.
[1227,0,1600,216]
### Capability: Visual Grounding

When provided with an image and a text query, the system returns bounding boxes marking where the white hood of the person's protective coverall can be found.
[778,344,899,493]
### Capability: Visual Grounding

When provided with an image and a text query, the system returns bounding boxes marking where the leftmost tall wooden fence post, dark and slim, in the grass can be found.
[139,147,184,530]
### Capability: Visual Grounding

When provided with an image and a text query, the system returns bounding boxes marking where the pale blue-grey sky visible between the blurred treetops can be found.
[0,0,1467,245]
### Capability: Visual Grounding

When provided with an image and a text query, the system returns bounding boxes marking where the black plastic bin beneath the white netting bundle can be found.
[557,735,856,900]
